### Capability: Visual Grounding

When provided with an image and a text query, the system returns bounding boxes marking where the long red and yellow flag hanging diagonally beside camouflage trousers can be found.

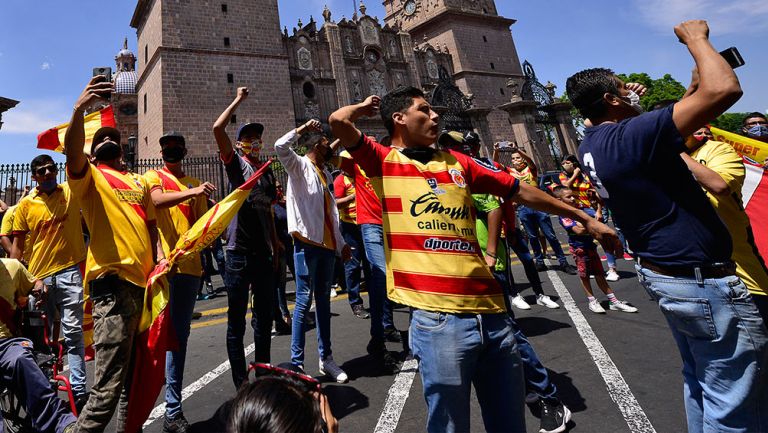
[126,161,271,431]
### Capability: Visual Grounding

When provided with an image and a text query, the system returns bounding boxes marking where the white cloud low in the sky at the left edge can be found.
[0,100,69,134]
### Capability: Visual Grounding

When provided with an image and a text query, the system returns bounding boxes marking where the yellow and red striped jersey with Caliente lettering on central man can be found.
[350,136,519,314]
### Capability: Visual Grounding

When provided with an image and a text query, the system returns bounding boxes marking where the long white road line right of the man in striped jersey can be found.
[546,260,656,433]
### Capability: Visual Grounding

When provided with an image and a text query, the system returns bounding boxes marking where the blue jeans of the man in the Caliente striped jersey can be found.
[410,309,525,433]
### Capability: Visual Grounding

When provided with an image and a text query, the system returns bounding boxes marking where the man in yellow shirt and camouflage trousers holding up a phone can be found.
[64,76,165,432]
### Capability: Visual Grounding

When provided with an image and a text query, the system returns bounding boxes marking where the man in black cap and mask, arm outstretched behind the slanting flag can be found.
[144,132,216,432]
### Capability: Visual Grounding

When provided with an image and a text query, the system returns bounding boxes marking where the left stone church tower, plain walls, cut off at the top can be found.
[131,0,295,158]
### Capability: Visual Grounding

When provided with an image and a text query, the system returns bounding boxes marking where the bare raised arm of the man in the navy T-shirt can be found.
[672,20,743,137]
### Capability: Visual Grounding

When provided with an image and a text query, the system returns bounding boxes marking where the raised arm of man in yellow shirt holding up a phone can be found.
[64,75,113,176]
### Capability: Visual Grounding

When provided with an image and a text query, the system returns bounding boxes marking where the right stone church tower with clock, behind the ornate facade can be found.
[383,0,523,141]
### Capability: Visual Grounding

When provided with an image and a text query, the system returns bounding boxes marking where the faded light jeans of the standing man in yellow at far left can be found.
[43,265,86,396]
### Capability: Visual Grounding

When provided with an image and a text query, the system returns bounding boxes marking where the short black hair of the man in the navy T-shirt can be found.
[565,68,619,119]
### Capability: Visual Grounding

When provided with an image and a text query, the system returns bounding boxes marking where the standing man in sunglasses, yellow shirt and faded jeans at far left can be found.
[11,155,87,411]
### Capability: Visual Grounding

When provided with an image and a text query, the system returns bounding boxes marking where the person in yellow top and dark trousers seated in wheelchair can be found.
[0,259,77,433]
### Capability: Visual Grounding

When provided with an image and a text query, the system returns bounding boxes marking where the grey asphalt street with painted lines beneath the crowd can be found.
[79,219,686,432]
